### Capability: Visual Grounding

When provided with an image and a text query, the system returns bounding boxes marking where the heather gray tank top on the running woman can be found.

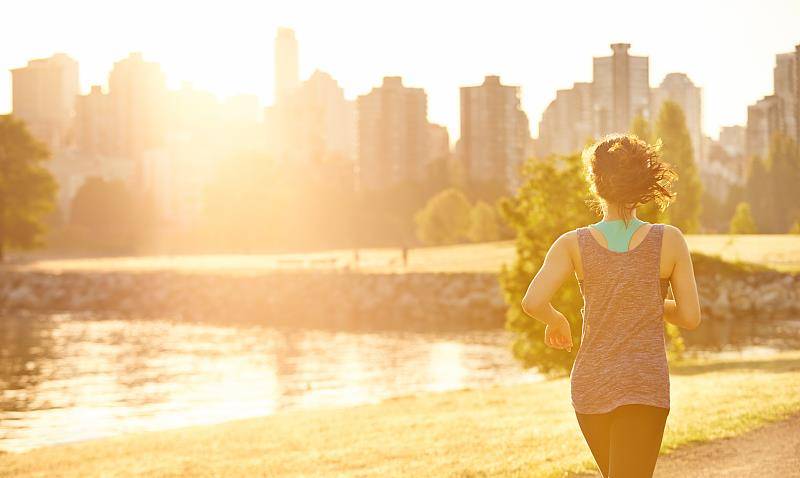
[570,224,670,413]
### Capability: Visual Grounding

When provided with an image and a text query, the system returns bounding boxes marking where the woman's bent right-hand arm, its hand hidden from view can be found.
[664,226,701,330]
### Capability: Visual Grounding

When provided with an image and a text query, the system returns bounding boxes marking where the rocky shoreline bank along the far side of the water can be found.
[0,254,800,336]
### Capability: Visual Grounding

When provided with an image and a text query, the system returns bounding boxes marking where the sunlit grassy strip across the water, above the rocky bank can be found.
[10,234,800,272]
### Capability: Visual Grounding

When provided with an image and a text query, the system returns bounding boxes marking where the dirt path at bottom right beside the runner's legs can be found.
[574,415,800,478]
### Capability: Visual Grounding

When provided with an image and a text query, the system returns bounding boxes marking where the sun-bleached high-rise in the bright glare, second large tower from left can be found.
[108,53,169,166]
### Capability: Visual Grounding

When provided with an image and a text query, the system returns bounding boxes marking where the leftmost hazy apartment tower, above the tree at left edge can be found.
[11,53,79,152]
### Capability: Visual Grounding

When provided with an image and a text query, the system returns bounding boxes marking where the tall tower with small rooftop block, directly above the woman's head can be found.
[592,43,650,136]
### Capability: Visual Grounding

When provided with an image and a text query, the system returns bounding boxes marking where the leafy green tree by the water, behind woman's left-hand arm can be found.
[499,153,597,373]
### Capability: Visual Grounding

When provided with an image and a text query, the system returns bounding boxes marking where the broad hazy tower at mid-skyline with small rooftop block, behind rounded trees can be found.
[357,76,430,190]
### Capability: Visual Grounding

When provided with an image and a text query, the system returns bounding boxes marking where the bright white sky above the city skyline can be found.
[0,0,800,139]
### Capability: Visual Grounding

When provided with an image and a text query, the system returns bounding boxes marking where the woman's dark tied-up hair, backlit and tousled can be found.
[583,134,678,224]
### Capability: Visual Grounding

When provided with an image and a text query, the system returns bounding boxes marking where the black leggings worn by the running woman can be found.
[575,405,669,478]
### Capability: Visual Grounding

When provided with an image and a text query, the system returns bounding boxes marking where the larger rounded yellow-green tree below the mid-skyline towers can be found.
[414,188,470,245]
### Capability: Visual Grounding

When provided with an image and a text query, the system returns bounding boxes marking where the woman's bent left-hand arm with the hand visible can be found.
[522,233,575,351]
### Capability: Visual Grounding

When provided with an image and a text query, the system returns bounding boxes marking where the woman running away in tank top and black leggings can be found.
[522,135,700,478]
